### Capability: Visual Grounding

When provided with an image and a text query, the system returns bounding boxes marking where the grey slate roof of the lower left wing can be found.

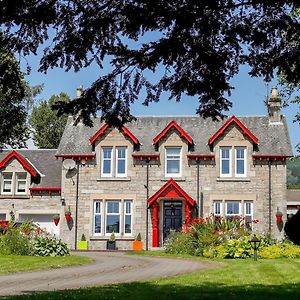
[0,149,62,188]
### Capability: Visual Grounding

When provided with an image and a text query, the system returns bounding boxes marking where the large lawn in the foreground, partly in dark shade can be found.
[2,253,300,300]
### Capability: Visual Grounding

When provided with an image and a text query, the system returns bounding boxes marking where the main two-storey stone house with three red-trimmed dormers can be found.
[0,89,292,249]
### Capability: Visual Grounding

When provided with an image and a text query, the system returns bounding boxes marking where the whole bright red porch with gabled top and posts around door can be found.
[148,178,196,247]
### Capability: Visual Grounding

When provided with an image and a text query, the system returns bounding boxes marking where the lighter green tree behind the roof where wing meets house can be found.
[29,93,70,149]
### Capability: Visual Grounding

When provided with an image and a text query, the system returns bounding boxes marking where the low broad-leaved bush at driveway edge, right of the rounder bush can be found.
[33,236,70,256]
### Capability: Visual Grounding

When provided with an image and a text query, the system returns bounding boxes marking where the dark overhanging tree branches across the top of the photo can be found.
[0,0,300,125]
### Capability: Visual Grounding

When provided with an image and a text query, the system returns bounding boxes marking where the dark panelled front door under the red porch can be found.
[163,201,182,241]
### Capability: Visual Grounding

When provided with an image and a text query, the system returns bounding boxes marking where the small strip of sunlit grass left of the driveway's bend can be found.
[0,255,92,274]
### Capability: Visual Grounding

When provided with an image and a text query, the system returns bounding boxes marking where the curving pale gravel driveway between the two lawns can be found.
[0,252,216,296]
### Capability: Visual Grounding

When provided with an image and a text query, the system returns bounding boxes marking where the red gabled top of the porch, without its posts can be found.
[148,178,196,206]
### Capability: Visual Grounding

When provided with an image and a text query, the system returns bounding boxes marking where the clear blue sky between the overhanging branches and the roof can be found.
[21,52,300,155]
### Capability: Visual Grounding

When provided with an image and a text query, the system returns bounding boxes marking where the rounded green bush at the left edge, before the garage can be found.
[0,228,32,255]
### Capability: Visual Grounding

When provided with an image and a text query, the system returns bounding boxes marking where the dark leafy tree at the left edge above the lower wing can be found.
[0,41,29,149]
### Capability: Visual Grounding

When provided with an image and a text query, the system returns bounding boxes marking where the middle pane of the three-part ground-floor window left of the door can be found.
[105,201,120,234]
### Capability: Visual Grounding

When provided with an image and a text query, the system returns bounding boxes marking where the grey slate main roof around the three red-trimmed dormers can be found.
[57,116,293,156]
